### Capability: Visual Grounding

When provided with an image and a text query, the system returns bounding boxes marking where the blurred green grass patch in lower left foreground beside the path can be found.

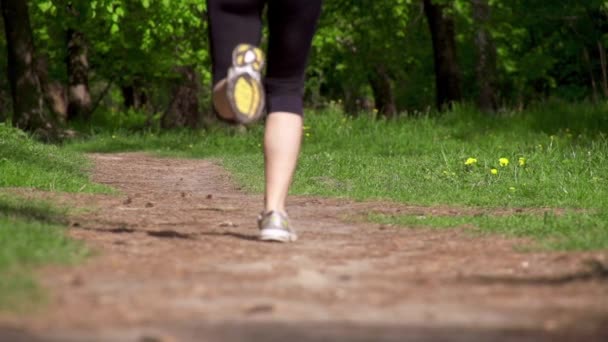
[0,193,88,311]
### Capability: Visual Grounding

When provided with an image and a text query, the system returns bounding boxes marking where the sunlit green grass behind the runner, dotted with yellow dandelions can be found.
[70,102,608,249]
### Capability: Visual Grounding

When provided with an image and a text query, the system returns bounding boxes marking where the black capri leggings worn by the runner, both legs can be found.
[207,0,322,115]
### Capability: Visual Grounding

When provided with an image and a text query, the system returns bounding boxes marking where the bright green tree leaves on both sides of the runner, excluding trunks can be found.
[0,0,608,115]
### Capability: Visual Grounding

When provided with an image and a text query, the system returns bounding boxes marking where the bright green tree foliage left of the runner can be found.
[31,0,211,99]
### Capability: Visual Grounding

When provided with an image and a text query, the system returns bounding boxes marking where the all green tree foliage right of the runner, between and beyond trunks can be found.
[309,0,608,110]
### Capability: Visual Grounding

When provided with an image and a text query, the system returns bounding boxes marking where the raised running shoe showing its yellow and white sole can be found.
[227,44,265,124]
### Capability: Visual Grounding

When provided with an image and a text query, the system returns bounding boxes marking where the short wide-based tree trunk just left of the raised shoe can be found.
[161,66,201,128]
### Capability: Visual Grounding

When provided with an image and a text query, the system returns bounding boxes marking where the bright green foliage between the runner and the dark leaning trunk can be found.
[309,0,420,108]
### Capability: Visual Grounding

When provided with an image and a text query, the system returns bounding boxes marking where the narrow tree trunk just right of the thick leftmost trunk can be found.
[66,29,91,122]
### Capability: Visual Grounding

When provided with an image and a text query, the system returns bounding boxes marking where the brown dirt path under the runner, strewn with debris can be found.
[0,154,608,341]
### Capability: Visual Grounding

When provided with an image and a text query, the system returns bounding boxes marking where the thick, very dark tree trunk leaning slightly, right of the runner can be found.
[423,0,462,110]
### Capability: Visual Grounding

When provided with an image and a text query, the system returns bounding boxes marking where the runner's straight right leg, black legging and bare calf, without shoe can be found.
[264,0,321,213]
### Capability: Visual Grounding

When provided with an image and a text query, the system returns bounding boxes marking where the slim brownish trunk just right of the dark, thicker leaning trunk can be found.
[471,0,498,113]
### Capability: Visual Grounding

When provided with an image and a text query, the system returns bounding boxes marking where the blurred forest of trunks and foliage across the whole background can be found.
[0,0,608,137]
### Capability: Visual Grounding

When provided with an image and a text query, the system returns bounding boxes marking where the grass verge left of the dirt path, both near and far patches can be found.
[0,124,103,311]
